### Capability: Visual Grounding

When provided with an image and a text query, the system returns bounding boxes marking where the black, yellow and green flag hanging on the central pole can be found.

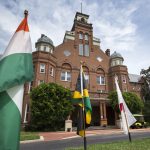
[72,67,92,136]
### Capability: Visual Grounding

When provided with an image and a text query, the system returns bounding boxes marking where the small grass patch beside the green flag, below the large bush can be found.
[20,132,40,141]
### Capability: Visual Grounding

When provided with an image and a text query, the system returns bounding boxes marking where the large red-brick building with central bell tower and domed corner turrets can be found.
[23,12,141,126]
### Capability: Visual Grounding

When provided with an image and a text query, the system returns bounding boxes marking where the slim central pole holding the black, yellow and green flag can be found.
[80,61,87,150]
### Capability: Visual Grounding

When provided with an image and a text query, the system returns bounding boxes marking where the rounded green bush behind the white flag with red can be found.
[108,91,144,114]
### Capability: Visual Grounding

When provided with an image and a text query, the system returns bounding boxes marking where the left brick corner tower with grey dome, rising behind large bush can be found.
[22,34,56,124]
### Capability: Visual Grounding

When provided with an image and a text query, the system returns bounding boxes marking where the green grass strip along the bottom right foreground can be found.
[66,138,150,150]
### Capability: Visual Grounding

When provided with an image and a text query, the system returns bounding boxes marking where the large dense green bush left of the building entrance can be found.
[30,83,72,131]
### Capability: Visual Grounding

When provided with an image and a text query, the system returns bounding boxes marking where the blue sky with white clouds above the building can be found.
[0,0,150,74]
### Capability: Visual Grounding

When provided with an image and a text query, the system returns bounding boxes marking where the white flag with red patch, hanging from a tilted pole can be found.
[115,77,136,134]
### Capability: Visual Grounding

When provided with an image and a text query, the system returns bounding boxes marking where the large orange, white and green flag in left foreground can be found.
[0,11,33,150]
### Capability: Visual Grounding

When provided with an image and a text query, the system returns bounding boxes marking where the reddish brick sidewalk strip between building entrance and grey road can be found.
[39,128,150,141]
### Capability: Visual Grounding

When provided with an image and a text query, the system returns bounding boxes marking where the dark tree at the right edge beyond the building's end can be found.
[141,67,150,121]
